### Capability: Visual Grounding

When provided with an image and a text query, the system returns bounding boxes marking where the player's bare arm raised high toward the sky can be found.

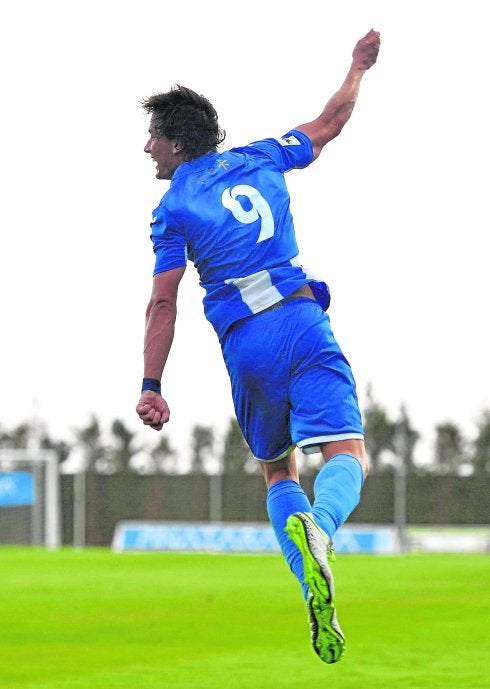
[295,29,380,159]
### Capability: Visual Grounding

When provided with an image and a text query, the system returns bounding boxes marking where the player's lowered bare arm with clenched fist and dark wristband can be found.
[136,268,185,431]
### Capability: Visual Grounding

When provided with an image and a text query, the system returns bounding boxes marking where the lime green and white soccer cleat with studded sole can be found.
[285,512,345,663]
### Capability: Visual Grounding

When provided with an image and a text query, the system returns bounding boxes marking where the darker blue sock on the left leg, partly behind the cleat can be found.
[267,479,311,598]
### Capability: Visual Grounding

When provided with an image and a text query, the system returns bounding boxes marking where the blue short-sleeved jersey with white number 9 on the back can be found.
[151,130,330,339]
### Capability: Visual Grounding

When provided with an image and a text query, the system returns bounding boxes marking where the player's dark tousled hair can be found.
[141,84,225,160]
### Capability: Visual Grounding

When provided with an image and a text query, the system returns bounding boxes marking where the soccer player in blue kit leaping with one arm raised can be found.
[136,30,380,663]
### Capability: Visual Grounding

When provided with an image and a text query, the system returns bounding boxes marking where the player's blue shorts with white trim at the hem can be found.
[221,297,363,462]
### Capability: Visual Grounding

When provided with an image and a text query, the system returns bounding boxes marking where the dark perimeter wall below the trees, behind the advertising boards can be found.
[62,473,490,546]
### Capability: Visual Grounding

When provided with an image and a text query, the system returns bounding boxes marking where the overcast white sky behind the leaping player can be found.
[0,0,490,462]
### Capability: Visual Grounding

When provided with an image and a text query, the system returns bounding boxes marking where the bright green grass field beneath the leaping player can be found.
[0,548,490,689]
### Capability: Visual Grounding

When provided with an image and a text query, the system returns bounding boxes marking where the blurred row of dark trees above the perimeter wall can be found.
[0,386,490,475]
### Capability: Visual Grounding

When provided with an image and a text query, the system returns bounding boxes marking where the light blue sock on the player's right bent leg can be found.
[312,454,364,538]
